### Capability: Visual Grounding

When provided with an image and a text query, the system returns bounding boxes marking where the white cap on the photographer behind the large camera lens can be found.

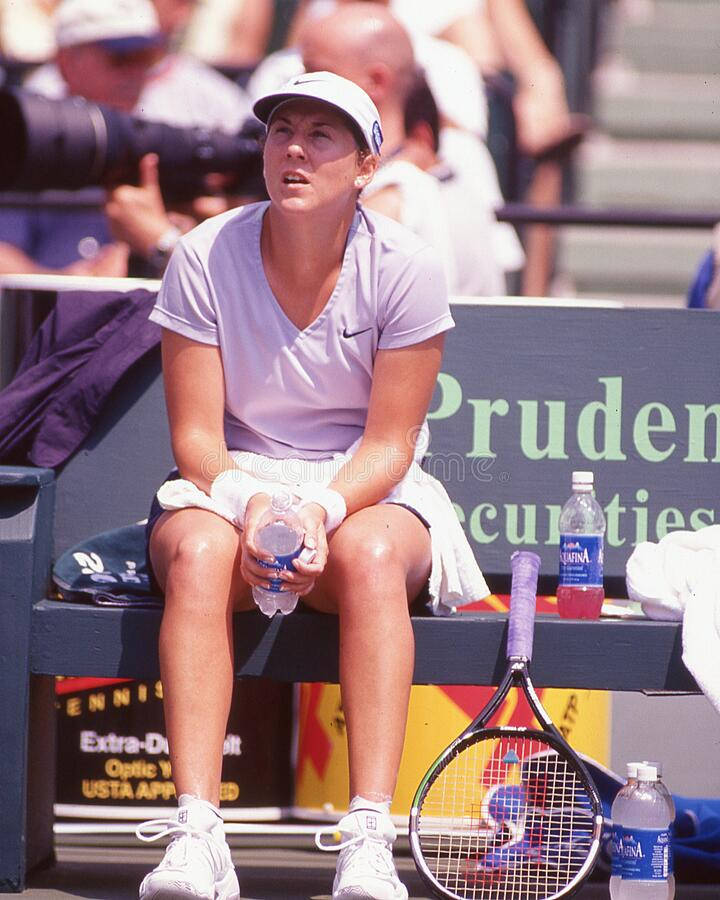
[55,0,162,52]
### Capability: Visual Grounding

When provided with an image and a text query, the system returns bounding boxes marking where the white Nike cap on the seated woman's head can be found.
[253,72,382,153]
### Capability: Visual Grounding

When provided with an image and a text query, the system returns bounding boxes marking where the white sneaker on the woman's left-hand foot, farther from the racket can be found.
[135,794,240,900]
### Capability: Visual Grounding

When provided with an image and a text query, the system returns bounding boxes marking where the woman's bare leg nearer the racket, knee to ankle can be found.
[306,504,431,800]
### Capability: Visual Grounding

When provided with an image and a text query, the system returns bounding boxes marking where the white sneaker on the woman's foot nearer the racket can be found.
[315,809,408,900]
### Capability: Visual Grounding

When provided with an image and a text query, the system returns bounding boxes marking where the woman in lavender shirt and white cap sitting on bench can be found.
[140,73,487,900]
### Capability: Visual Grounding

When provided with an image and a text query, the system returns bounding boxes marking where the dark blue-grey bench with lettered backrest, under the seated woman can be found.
[0,304,720,891]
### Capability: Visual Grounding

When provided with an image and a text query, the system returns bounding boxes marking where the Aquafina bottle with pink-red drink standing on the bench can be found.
[557,472,605,619]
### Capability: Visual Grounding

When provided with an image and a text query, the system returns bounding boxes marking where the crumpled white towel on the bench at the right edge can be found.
[626,525,720,713]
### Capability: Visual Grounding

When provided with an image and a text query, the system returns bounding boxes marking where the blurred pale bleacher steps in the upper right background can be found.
[557,0,720,306]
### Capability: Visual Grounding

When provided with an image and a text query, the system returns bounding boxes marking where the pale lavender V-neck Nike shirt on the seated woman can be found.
[150,202,454,459]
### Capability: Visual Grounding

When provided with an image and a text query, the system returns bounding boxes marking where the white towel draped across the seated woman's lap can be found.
[157,441,490,615]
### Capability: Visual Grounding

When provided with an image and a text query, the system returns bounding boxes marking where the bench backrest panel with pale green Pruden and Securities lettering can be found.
[427,305,720,592]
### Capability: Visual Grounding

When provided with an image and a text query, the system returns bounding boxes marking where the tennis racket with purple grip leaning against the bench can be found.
[410,551,603,900]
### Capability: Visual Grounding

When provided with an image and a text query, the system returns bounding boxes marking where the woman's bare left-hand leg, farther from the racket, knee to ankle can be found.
[150,509,248,805]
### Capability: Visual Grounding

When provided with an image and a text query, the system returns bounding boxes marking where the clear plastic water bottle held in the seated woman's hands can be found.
[252,490,305,617]
